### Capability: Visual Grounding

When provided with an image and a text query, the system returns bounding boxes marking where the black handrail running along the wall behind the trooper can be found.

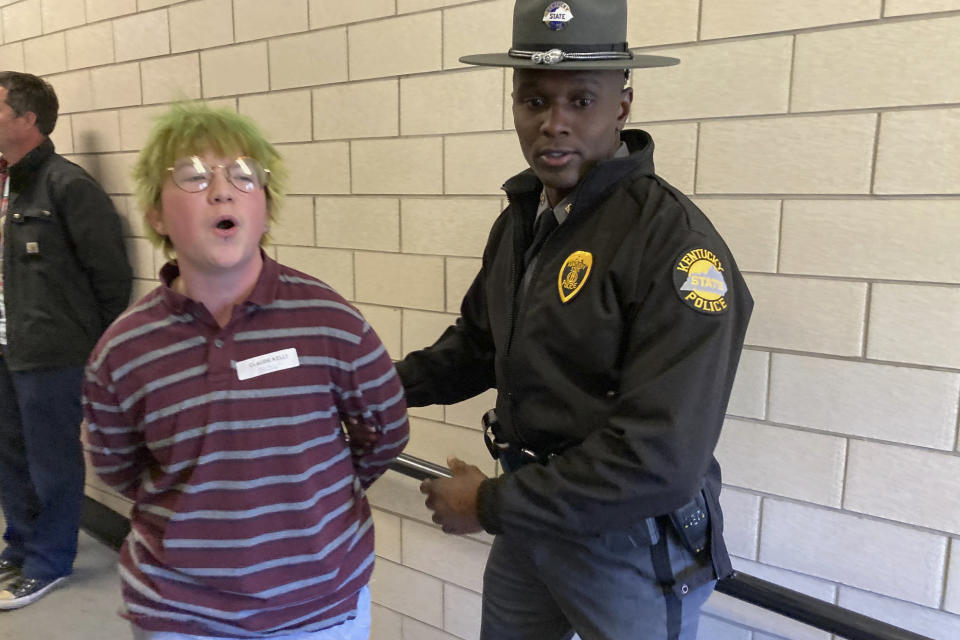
[390,453,931,640]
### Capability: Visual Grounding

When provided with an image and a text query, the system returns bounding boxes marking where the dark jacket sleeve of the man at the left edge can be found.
[54,177,133,331]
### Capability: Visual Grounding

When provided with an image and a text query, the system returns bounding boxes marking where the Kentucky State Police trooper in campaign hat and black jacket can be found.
[398,0,753,640]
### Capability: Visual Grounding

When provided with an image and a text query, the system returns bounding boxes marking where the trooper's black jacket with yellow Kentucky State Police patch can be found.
[398,131,753,577]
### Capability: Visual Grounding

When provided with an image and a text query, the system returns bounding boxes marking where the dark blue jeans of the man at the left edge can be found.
[0,356,85,580]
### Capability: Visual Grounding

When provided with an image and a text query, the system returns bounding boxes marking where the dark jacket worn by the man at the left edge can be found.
[3,139,133,371]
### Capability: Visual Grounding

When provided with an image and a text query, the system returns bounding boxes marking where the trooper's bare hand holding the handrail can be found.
[420,457,487,534]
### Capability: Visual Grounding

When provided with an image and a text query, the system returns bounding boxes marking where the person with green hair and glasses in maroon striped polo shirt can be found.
[84,104,409,640]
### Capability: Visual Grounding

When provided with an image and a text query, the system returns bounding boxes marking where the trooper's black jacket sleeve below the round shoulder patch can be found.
[478,232,753,534]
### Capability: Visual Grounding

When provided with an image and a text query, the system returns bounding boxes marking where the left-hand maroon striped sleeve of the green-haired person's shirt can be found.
[83,350,152,500]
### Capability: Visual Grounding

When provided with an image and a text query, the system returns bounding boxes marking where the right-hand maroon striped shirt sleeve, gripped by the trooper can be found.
[340,322,410,488]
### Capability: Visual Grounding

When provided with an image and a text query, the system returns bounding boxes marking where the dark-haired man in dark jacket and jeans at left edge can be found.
[0,72,132,610]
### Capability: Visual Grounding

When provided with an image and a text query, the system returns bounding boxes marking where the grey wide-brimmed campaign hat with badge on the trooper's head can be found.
[460,0,680,71]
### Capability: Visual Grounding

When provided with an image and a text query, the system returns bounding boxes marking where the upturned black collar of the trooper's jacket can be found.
[501,129,654,215]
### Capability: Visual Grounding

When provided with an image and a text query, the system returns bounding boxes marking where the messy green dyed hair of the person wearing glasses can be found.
[133,102,287,254]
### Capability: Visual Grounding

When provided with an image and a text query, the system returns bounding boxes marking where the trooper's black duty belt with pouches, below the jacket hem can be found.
[483,409,710,554]
